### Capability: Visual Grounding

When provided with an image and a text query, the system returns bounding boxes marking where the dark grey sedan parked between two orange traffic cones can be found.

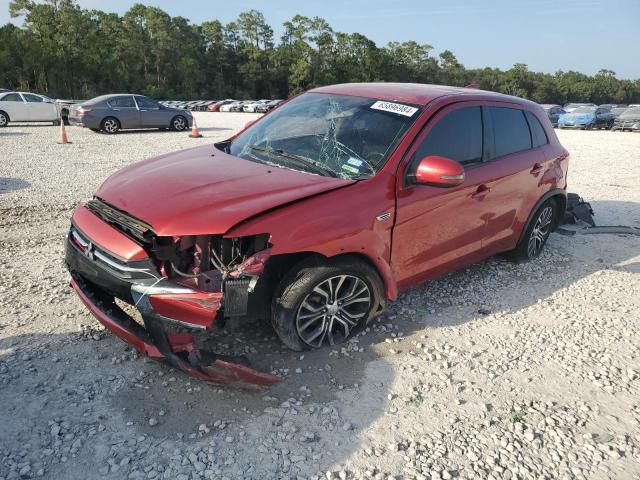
[69,94,193,133]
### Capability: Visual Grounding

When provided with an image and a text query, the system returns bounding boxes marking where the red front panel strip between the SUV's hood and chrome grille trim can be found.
[71,205,149,260]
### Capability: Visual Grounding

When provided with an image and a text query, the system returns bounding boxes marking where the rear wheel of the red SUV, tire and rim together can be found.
[506,198,558,263]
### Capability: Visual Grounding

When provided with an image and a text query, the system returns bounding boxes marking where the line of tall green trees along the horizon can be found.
[0,0,640,104]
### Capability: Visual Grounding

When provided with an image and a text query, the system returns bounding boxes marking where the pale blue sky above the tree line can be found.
[0,0,640,79]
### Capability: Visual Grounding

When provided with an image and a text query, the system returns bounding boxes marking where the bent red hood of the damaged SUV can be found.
[96,145,354,236]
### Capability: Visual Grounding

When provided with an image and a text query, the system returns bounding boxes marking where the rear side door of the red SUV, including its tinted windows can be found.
[482,103,548,253]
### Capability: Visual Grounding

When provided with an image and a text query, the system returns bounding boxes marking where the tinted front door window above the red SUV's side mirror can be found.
[414,107,483,165]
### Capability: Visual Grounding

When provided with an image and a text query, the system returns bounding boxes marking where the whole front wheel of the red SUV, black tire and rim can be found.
[272,257,386,351]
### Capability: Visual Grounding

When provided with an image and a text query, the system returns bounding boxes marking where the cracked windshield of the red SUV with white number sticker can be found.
[227,93,419,179]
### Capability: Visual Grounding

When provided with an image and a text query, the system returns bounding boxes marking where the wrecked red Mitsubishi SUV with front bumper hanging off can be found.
[66,83,568,384]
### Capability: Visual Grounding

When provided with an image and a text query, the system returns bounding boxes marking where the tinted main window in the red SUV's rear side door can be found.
[489,107,531,158]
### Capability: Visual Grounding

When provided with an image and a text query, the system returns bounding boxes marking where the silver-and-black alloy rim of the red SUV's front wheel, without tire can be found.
[296,275,371,348]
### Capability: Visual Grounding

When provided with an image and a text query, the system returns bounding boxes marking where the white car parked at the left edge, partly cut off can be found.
[0,92,60,127]
